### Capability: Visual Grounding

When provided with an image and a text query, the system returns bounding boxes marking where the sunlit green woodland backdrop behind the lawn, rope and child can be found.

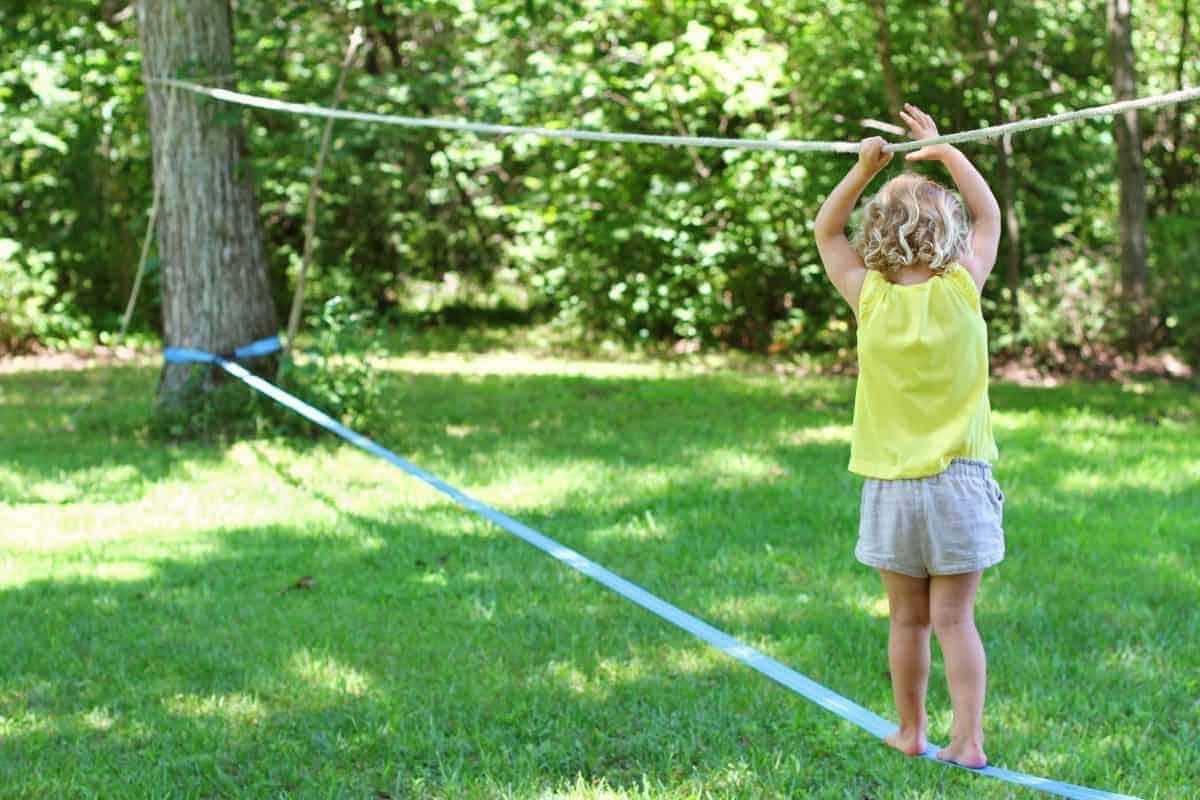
[0,0,1200,356]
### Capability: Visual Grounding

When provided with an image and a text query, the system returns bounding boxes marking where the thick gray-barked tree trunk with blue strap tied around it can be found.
[138,0,278,405]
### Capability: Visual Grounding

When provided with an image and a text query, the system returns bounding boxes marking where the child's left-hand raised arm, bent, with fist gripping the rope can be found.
[812,137,892,315]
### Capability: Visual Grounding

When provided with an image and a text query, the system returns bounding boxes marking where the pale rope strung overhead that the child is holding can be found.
[148,78,1200,152]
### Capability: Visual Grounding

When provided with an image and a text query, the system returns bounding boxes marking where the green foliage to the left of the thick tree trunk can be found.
[0,0,154,344]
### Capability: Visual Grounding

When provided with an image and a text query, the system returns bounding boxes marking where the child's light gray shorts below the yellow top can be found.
[854,458,1004,578]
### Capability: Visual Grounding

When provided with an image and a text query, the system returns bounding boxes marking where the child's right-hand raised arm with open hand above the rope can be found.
[900,103,1001,291]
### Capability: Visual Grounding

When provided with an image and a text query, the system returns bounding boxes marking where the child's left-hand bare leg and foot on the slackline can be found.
[880,570,930,756]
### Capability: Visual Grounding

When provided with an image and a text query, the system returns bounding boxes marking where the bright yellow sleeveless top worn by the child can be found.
[850,264,998,480]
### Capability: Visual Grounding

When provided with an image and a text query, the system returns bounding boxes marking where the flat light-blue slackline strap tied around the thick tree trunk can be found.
[167,338,1140,800]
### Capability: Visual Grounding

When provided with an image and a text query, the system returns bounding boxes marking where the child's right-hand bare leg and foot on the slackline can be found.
[929,571,988,768]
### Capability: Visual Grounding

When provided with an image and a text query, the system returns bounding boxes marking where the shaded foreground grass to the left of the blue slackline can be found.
[0,496,892,796]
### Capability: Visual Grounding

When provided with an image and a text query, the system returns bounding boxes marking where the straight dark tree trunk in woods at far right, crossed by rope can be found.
[1108,0,1150,348]
